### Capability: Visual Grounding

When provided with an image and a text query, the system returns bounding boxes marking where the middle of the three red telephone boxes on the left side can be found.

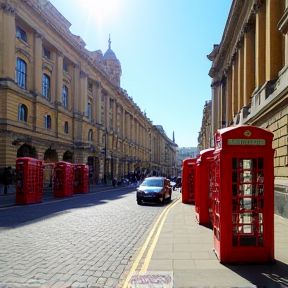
[53,161,74,198]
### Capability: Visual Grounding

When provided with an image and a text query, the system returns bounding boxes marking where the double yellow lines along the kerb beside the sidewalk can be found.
[122,198,181,288]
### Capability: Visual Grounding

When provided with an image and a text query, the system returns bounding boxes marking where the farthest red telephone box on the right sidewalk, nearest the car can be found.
[181,158,197,204]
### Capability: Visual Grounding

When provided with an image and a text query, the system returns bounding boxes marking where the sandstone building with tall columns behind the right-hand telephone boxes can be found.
[199,0,288,180]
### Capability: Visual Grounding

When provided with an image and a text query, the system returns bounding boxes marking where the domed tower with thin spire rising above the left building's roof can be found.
[102,35,122,87]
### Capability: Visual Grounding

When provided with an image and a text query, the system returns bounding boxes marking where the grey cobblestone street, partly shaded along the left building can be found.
[0,187,180,288]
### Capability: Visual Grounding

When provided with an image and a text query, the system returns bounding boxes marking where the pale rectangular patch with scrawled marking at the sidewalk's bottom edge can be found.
[127,271,173,288]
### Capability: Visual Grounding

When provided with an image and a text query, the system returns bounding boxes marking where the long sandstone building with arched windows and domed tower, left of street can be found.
[0,0,177,192]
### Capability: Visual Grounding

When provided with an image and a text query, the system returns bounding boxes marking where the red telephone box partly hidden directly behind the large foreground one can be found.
[195,148,214,225]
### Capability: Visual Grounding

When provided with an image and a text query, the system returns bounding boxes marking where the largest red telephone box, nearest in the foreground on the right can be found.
[210,125,274,262]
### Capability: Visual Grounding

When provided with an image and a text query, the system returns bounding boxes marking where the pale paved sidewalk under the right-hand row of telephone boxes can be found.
[143,200,288,288]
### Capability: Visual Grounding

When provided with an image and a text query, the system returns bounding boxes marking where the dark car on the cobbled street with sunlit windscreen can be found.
[136,177,172,205]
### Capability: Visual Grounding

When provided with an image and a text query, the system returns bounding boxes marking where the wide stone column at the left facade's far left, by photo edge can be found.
[0,3,16,80]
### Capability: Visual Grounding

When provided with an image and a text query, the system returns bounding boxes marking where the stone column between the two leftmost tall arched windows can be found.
[33,33,43,94]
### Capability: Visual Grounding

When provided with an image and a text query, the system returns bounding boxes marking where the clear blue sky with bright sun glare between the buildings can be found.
[50,0,232,147]
